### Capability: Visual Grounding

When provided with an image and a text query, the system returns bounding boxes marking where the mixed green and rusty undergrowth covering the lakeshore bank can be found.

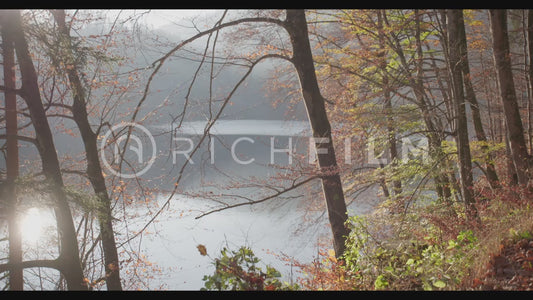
[200,180,533,290]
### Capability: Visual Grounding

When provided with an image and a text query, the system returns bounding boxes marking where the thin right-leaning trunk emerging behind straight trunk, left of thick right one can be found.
[450,10,500,189]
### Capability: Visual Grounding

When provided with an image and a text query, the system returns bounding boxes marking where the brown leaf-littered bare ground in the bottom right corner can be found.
[472,238,533,291]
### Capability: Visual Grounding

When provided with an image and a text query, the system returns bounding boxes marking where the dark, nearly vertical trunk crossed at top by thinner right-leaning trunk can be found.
[447,9,478,220]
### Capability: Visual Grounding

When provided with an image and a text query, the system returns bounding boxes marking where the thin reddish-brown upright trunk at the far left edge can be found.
[0,16,24,291]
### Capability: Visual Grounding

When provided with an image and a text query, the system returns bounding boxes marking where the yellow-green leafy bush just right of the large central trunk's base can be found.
[344,217,477,290]
